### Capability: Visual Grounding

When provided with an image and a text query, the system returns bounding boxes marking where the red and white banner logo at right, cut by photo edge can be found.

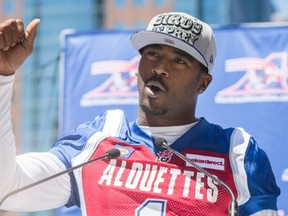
[215,52,288,104]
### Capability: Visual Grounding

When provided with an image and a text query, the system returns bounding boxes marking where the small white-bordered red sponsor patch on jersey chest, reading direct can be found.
[186,153,226,171]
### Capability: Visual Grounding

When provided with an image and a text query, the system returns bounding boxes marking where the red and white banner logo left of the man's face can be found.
[80,55,140,107]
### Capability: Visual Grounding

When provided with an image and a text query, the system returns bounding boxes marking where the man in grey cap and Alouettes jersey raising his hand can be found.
[0,12,280,216]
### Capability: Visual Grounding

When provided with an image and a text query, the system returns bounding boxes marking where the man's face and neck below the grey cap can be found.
[137,45,212,126]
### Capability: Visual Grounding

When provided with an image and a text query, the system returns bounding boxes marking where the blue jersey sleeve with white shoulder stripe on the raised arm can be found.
[50,110,126,207]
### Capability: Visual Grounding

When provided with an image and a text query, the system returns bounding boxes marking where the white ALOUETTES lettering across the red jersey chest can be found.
[98,159,219,203]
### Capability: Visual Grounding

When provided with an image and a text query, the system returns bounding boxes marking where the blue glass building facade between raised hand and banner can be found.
[20,0,103,152]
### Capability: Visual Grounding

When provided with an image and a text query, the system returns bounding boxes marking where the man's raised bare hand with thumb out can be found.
[0,19,40,76]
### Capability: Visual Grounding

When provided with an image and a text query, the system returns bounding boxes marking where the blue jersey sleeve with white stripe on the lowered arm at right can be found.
[231,129,280,215]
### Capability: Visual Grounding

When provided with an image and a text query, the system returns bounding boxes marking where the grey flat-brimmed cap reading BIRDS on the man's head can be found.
[131,12,216,73]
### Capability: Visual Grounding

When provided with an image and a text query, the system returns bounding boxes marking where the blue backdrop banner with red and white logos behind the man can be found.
[58,26,288,215]
